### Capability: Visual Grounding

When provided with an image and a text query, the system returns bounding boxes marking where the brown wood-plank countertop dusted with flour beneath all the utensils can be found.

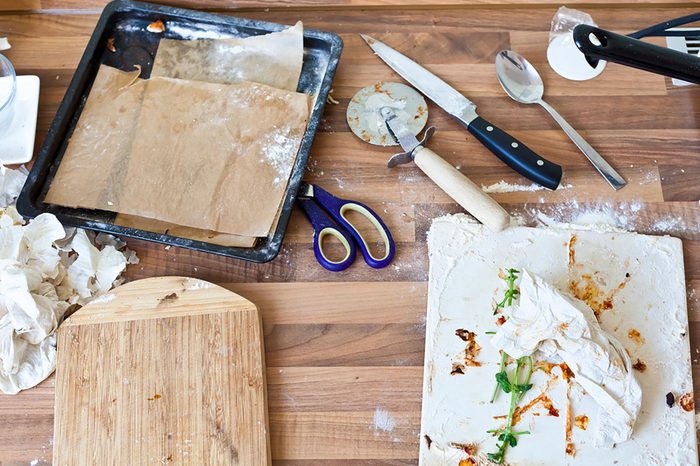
[0,0,700,466]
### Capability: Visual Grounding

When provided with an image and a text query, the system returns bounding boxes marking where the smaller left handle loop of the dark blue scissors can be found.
[297,197,357,272]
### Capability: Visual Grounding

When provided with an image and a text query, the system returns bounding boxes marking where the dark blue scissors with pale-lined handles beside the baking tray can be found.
[297,183,396,272]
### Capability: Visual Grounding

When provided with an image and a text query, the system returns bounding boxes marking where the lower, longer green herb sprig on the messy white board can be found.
[486,353,532,464]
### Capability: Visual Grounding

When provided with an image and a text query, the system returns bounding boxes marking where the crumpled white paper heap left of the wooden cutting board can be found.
[0,167,138,394]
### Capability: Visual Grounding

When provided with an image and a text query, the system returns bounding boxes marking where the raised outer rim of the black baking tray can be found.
[16,0,343,263]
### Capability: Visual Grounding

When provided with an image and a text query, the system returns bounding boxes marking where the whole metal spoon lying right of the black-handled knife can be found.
[496,50,627,190]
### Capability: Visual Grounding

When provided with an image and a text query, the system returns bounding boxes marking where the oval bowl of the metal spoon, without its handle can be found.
[496,50,544,104]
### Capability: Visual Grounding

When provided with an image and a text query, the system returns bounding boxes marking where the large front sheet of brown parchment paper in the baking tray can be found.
[46,67,309,237]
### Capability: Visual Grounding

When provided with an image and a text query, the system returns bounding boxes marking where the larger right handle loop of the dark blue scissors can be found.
[313,185,396,269]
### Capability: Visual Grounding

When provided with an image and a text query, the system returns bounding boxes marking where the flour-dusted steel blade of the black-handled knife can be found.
[360,34,478,126]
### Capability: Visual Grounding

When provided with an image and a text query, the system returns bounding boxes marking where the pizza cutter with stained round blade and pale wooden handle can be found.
[347,82,510,231]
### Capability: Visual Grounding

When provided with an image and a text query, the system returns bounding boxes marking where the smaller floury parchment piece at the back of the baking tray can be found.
[151,21,304,91]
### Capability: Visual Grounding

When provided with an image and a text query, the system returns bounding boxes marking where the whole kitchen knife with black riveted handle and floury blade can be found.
[360,34,562,189]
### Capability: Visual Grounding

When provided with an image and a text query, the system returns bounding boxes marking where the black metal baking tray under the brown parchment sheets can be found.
[17,0,343,262]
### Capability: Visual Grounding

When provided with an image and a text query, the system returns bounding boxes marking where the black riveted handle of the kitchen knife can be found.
[467,117,562,190]
